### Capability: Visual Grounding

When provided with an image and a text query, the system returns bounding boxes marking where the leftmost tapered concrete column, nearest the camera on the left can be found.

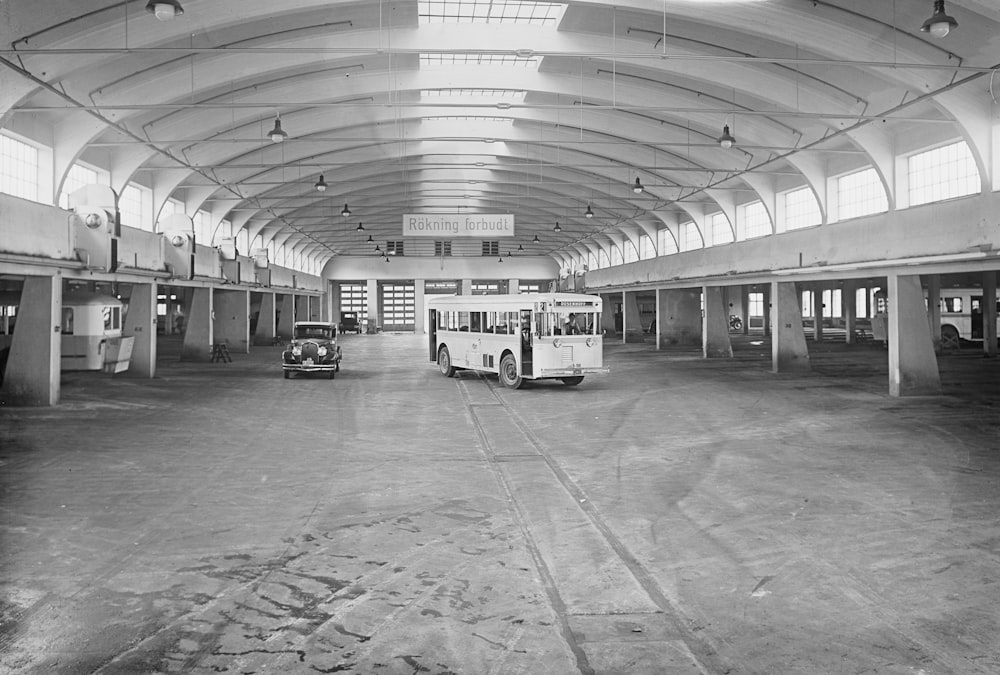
[0,276,62,406]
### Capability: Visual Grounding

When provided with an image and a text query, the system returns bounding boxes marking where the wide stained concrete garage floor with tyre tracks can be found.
[0,335,1000,675]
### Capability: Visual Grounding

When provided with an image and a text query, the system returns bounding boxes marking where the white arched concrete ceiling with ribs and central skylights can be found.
[0,0,1000,264]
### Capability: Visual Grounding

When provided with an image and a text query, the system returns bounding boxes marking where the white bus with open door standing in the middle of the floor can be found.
[427,293,609,389]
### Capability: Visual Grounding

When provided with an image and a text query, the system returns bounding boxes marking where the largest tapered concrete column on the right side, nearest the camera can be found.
[888,274,941,396]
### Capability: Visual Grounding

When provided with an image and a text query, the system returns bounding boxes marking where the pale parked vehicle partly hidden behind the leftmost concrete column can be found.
[62,293,124,370]
